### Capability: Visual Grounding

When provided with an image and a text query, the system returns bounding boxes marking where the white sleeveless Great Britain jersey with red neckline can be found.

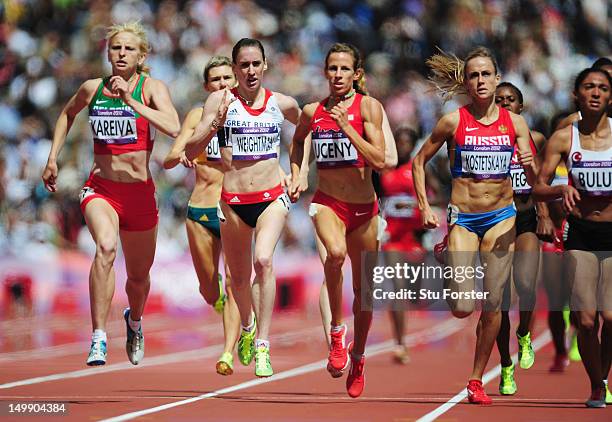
[225,88,285,161]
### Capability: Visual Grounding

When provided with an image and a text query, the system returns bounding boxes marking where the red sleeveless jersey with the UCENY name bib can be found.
[310,93,366,169]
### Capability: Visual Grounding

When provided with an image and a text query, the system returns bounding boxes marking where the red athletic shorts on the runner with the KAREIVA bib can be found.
[79,175,158,231]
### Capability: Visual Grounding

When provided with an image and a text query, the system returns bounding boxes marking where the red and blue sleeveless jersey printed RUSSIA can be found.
[449,106,516,180]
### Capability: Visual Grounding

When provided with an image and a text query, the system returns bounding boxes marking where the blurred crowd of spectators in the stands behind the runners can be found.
[0,0,612,256]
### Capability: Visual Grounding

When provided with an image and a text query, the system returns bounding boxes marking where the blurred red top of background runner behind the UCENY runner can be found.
[380,160,421,237]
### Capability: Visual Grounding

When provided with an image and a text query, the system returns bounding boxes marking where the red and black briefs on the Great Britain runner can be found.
[219,184,291,228]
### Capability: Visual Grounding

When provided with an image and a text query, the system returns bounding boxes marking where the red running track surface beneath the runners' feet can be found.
[0,312,612,422]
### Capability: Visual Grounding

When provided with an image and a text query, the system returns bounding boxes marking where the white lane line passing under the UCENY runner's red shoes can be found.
[101,319,466,422]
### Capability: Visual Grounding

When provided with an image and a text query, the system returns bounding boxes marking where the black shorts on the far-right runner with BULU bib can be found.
[564,214,612,256]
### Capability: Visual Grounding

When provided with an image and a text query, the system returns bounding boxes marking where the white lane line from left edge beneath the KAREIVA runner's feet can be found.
[0,325,328,390]
